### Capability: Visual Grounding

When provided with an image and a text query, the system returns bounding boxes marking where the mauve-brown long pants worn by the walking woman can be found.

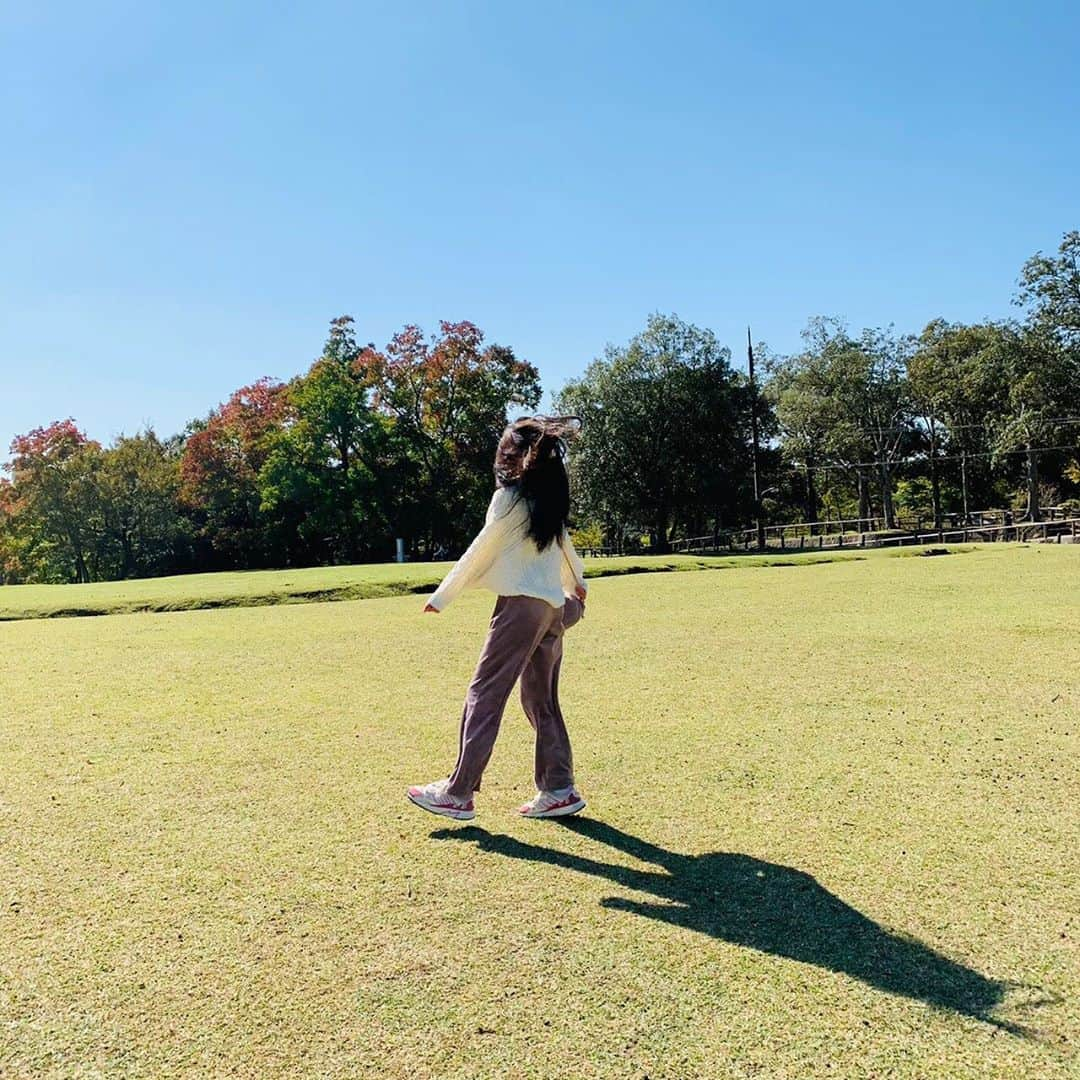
[449,596,584,799]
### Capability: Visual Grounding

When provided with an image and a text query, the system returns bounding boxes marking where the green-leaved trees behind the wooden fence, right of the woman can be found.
[556,232,1080,551]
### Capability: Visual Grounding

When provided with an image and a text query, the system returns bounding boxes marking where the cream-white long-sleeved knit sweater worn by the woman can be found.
[427,487,586,611]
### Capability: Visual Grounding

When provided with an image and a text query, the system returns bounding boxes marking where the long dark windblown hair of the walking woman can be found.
[495,416,581,551]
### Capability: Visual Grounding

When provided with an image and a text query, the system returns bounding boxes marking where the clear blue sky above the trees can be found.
[0,0,1080,459]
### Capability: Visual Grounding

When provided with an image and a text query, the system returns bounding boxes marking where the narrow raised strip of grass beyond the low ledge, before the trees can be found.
[0,549,959,622]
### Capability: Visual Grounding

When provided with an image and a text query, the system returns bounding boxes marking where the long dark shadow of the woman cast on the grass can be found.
[432,818,1045,1035]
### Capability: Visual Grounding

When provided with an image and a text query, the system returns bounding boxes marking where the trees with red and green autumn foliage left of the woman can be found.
[0,316,540,582]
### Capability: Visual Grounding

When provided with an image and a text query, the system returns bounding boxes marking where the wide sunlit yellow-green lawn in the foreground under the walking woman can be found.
[0,545,1080,1080]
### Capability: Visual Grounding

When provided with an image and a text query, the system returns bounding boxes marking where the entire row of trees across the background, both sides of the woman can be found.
[0,232,1080,583]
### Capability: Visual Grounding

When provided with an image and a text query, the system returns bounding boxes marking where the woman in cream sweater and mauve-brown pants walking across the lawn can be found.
[408,417,585,821]
